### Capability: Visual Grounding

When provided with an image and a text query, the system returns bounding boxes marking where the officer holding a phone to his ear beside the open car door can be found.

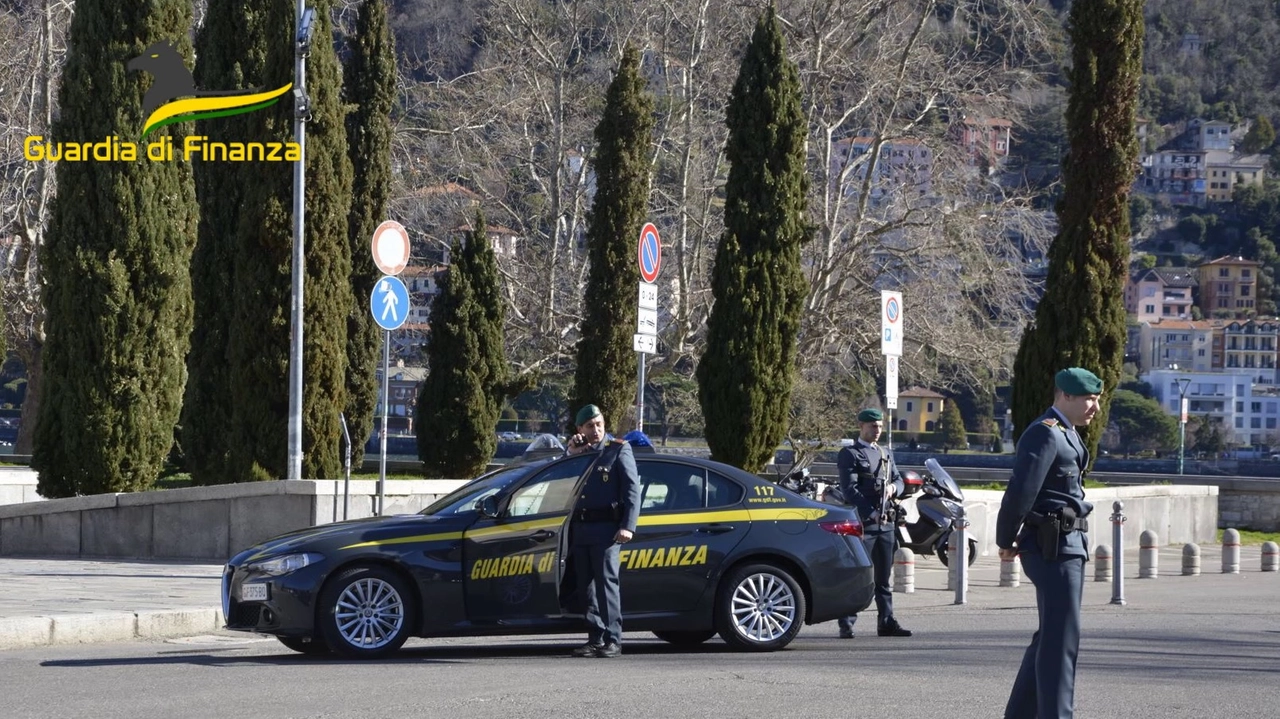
[566,404,640,659]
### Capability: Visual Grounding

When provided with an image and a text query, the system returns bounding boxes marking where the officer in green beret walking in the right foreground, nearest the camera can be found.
[996,367,1102,719]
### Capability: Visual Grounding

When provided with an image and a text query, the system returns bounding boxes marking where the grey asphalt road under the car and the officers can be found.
[0,548,1280,719]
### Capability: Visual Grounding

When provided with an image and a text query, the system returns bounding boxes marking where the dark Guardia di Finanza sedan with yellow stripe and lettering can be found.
[221,453,873,658]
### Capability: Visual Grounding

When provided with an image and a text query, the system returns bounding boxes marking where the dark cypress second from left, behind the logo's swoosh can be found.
[180,0,266,485]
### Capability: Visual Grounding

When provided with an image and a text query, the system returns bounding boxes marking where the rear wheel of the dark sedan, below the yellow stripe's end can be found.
[716,564,805,651]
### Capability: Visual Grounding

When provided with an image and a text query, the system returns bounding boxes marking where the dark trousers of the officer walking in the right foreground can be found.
[1005,553,1084,719]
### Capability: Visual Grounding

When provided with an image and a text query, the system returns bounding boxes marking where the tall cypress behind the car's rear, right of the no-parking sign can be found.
[698,11,812,471]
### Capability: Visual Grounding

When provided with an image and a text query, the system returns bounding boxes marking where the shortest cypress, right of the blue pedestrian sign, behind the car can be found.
[413,223,498,478]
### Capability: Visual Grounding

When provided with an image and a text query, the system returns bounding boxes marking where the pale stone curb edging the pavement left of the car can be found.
[0,606,223,651]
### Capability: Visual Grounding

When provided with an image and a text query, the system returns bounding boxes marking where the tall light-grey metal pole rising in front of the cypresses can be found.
[288,0,307,480]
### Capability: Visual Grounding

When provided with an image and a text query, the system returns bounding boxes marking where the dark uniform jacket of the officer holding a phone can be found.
[573,438,640,544]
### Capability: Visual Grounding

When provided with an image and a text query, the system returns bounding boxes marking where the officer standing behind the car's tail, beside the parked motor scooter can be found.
[836,408,911,640]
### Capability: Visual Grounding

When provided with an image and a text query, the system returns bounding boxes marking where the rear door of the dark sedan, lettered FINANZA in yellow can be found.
[620,458,749,615]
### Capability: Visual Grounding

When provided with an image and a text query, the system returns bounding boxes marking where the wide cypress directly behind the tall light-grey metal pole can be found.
[228,0,352,478]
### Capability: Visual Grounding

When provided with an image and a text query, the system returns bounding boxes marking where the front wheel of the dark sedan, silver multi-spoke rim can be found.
[320,567,415,658]
